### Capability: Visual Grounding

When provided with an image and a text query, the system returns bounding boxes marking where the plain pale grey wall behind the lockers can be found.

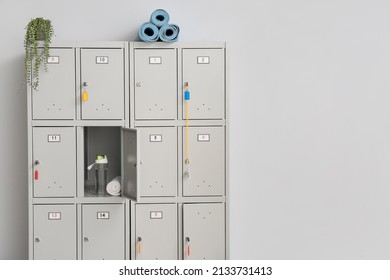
[0,0,390,259]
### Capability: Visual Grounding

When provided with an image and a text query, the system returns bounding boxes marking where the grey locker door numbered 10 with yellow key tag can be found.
[81,49,124,120]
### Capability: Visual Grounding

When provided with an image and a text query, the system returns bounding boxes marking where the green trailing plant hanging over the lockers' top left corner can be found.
[24,18,54,90]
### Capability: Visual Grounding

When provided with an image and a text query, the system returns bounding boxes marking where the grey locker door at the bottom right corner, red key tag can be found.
[183,203,226,260]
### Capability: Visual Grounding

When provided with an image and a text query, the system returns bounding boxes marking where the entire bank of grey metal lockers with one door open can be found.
[27,41,229,260]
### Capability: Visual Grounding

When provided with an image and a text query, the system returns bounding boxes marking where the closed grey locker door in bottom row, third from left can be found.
[134,204,177,260]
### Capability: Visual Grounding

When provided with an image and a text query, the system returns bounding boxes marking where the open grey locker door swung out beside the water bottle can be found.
[122,128,140,202]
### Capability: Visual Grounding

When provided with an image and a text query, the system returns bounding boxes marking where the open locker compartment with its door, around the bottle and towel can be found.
[83,126,140,201]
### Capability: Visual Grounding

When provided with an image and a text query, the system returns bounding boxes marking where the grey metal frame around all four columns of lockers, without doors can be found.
[27,41,229,259]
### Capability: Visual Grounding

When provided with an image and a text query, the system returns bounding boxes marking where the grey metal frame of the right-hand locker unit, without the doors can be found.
[130,42,230,259]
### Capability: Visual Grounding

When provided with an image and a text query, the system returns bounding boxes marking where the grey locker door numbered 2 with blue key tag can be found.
[183,49,225,119]
